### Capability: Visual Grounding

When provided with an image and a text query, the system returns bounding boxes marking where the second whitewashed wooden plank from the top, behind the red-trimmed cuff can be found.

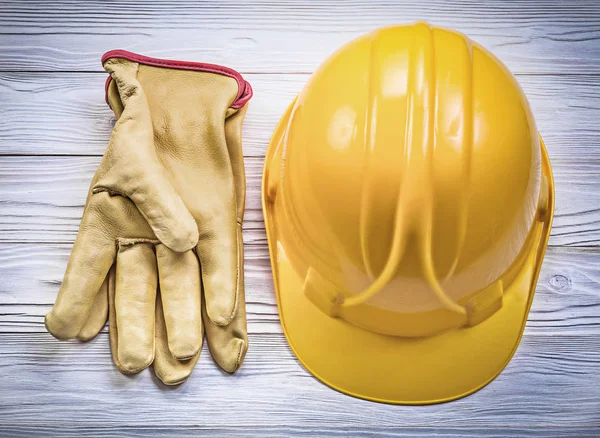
[0,72,600,160]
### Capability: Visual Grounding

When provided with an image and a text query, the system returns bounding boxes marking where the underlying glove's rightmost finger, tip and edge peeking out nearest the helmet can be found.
[202,226,248,373]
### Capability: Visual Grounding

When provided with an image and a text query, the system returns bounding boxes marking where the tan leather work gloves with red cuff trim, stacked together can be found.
[45,51,252,384]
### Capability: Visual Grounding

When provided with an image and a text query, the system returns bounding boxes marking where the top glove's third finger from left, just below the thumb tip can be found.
[156,244,203,360]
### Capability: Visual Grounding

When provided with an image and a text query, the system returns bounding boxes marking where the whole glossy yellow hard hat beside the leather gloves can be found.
[262,23,554,404]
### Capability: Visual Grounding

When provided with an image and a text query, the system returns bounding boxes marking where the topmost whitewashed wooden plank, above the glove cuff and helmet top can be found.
[0,0,600,74]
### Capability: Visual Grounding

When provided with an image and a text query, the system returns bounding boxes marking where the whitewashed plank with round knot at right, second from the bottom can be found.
[0,243,600,336]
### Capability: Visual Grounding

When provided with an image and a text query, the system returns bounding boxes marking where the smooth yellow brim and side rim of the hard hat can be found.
[262,102,554,405]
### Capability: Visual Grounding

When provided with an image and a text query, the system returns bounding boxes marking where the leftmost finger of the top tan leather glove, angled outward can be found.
[44,204,116,339]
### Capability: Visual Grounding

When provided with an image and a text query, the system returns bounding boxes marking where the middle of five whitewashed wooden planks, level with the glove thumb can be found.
[0,154,600,247]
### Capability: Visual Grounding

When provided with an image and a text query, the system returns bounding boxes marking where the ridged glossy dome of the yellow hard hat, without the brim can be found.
[270,23,542,336]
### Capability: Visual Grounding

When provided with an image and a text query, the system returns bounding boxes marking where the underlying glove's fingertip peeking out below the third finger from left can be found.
[152,293,202,385]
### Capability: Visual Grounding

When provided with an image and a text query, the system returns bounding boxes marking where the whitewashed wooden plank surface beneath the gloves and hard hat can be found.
[0,0,600,437]
